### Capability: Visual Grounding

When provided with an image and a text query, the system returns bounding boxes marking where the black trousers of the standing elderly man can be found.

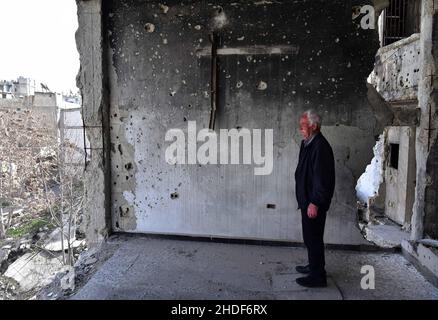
[301,209,327,277]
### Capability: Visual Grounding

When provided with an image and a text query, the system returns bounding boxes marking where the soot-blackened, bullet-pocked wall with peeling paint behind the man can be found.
[103,0,379,244]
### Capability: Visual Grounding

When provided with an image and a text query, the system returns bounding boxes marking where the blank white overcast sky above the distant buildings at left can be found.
[0,0,79,92]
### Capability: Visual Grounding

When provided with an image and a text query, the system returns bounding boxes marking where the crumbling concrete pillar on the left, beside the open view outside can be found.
[76,0,111,247]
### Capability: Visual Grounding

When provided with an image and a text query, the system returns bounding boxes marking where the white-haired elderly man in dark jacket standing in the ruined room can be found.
[295,110,335,287]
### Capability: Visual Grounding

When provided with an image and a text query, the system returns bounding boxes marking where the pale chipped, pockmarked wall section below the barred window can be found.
[369,33,420,102]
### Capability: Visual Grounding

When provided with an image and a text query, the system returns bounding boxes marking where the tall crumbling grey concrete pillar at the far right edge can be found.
[411,0,438,240]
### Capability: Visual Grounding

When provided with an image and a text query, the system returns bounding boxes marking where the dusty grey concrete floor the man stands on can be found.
[72,235,438,300]
